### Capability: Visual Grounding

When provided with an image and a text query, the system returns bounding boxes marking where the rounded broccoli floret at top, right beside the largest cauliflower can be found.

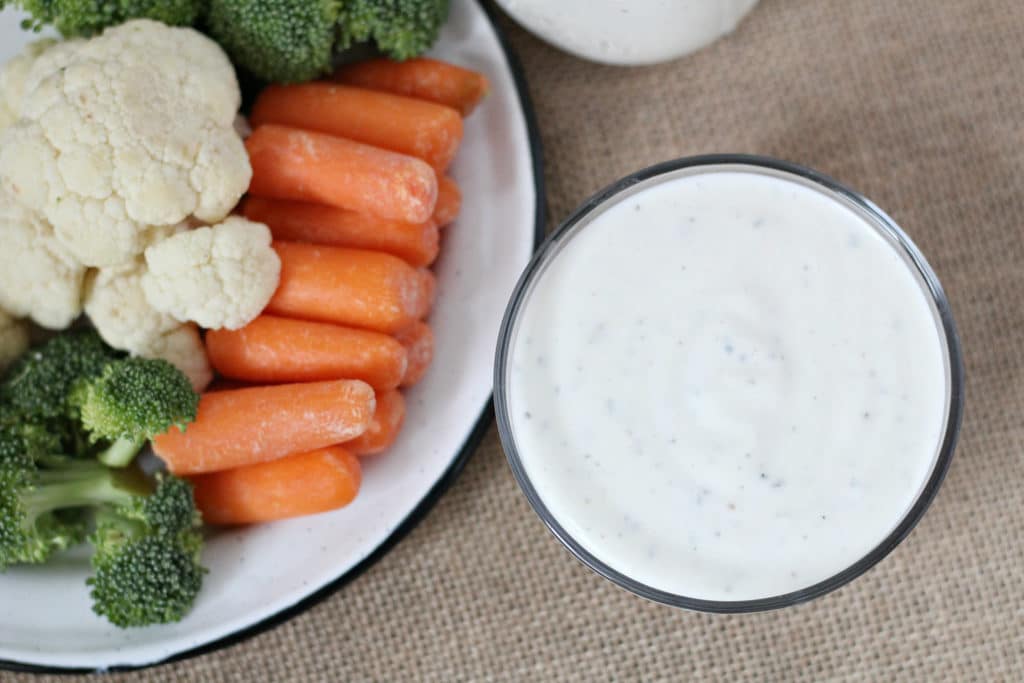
[206,0,340,83]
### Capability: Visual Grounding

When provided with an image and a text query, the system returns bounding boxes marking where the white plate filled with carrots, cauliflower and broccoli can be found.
[0,0,544,672]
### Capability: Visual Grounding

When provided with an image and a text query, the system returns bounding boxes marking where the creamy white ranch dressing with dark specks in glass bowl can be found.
[507,170,949,601]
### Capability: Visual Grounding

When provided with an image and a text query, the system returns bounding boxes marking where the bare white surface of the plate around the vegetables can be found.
[0,0,543,670]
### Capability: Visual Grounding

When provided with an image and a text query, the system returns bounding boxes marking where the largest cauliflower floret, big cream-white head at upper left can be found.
[0,19,252,267]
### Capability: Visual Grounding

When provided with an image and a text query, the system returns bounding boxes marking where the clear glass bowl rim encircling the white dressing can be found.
[494,154,964,613]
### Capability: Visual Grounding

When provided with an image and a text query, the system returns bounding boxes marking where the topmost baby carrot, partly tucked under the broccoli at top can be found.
[334,57,489,116]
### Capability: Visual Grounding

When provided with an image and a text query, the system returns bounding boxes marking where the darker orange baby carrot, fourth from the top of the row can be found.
[242,193,440,266]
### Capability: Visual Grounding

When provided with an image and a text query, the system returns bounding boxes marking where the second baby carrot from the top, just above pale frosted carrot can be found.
[250,82,462,171]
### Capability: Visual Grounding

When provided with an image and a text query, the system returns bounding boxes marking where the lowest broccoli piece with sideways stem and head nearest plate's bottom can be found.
[0,425,204,627]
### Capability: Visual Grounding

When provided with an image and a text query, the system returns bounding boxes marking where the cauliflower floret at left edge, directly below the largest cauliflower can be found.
[0,193,85,330]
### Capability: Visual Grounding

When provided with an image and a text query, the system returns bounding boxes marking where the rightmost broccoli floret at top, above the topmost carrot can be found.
[338,0,449,59]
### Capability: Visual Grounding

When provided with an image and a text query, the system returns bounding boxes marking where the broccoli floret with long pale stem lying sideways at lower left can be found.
[0,458,148,568]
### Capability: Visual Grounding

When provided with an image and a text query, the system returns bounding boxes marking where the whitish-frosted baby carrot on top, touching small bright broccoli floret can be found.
[153,380,376,474]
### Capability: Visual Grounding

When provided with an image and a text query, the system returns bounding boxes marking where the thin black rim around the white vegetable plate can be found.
[0,1,547,674]
